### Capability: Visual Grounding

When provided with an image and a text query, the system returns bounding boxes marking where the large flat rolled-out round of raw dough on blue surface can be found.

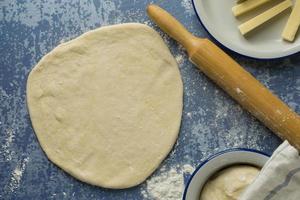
[27,23,183,188]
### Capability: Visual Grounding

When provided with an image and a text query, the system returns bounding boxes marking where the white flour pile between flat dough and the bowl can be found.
[142,164,194,200]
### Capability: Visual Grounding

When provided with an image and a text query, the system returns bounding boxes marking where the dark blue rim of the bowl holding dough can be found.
[182,148,271,200]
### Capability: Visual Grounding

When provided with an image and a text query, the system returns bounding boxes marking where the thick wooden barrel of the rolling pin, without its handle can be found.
[190,40,300,149]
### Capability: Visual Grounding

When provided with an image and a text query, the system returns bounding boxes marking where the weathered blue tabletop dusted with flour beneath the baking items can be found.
[0,0,300,200]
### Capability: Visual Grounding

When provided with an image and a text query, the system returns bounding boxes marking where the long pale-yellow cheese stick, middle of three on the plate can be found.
[239,0,293,35]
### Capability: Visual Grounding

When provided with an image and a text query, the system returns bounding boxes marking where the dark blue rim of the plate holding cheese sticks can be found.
[191,0,300,61]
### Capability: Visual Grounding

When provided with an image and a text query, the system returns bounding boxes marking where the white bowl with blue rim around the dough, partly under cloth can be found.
[183,149,269,200]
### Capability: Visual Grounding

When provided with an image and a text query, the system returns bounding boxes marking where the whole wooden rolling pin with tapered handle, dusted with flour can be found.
[147,5,300,150]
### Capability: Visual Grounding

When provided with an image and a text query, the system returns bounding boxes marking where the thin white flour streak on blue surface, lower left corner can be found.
[8,157,29,192]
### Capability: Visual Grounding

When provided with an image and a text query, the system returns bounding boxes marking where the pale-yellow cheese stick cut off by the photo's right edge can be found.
[282,0,300,42]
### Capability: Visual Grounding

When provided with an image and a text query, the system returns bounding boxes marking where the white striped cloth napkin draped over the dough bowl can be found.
[240,141,300,200]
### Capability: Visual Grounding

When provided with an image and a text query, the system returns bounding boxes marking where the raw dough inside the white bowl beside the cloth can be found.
[200,165,260,200]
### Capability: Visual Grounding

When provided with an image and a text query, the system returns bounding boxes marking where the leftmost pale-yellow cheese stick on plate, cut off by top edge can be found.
[232,0,272,17]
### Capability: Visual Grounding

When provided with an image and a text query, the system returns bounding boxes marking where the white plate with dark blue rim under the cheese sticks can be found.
[193,0,300,59]
